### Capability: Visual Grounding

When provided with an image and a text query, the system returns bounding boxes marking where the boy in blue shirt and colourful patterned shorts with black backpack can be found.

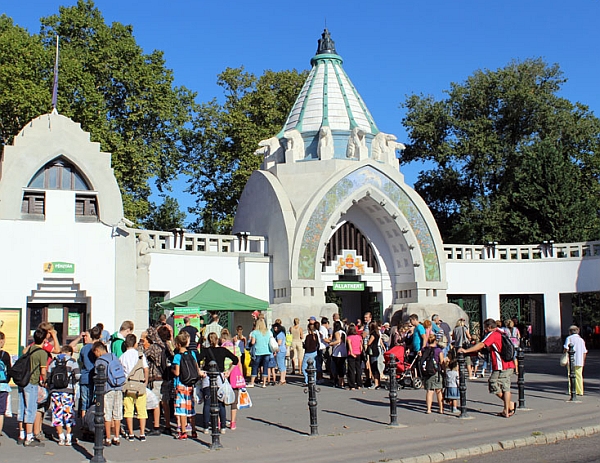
[171,331,201,440]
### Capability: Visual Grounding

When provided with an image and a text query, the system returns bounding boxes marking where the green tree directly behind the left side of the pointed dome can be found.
[184,67,307,233]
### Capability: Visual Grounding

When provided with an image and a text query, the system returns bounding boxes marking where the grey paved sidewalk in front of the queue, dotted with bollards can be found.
[0,351,600,463]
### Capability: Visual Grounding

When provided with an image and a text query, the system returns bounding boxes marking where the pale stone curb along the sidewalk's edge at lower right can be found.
[389,425,600,463]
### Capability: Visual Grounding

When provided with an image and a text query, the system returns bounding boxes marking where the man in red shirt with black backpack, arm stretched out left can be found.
[458,318,517,418]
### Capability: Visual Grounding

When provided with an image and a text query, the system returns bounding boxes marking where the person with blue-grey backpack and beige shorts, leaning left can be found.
[92,341,126,447]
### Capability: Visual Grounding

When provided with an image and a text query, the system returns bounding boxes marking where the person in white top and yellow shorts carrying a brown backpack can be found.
[119,334,148,442]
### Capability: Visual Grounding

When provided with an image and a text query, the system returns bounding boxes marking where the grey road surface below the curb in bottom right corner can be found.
[455,434,600,463]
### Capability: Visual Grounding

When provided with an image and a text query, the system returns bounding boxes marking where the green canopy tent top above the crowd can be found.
[158,280,269,312]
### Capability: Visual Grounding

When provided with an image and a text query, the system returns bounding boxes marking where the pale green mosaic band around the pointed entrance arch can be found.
[298,166,440,281]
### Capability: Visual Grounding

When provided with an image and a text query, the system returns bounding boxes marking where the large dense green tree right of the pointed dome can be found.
[402,59,600,244]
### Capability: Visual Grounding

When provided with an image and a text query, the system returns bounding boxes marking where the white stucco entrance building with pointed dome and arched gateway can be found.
[0,31,600,356]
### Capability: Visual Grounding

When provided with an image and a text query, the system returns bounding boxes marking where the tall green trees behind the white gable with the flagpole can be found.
[0,0,195,223]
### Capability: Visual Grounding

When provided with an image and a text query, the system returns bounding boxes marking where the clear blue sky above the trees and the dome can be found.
[0,0,600,221]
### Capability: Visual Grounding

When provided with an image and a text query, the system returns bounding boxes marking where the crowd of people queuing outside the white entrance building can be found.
[0,312,587,447]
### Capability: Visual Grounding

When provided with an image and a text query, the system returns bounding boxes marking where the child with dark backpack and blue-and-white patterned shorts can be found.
[47,346,81,447]
